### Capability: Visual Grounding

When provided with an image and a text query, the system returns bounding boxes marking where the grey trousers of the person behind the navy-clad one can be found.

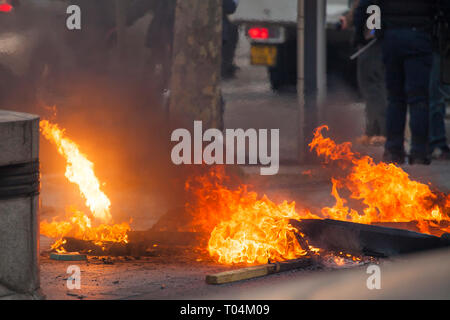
[358,42,387,137]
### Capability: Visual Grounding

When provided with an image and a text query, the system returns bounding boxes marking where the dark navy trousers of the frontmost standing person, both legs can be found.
[383,28,433,157]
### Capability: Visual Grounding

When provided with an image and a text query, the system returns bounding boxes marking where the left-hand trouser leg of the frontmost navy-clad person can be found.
[383,31,407,163]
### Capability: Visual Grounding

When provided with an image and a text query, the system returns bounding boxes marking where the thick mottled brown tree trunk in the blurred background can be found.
[169,0,222,129]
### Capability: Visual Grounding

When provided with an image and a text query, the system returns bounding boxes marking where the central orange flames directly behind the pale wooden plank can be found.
[186,167,317,264]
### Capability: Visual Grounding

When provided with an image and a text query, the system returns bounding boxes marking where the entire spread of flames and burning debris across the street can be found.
[41,121,450,270]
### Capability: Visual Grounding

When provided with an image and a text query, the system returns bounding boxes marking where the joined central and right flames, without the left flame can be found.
[186,126,450,264]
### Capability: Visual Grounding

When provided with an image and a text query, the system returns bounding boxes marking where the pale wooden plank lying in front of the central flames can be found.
[205,257,313,284]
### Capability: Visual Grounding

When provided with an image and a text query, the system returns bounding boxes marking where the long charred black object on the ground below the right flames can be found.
[291,219,450,257]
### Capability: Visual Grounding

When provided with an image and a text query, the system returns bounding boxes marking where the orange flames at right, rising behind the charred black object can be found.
[309,126,450,233]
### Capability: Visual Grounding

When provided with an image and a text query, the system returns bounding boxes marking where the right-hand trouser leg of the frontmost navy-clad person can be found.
[404,31,433,163]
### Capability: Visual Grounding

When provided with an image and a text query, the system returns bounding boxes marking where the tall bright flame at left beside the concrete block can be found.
[40,120,130,251]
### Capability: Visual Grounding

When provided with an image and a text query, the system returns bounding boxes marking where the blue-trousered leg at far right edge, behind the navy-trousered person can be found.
[430,52,448,154]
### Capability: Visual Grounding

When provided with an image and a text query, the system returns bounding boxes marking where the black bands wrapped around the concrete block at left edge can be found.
[0,161,40,199]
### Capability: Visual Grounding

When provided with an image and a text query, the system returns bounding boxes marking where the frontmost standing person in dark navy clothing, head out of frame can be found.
[358,0,437,165]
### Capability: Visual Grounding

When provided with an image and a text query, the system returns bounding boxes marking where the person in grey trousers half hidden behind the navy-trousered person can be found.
[341,0,387,145]
